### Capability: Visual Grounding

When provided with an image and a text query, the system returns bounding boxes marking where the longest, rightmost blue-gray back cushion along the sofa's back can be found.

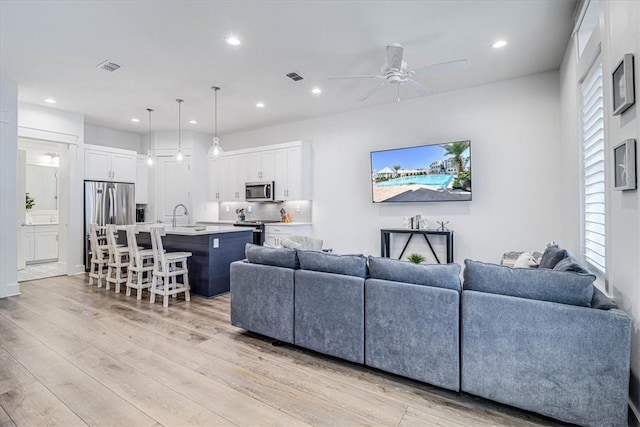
[463,259,596,307]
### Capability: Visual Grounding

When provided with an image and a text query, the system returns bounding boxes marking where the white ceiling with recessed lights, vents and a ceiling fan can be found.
[0,0,576,135]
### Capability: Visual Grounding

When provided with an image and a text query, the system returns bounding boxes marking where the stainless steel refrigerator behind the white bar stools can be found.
[84,181,136,271]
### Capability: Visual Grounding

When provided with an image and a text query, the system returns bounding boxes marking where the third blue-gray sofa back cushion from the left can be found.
[369,256,461,292]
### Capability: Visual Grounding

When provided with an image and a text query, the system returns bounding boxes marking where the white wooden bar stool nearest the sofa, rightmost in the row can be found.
[149,227,192,307]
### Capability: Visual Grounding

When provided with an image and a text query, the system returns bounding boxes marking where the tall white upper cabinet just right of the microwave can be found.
[274,141,312,200]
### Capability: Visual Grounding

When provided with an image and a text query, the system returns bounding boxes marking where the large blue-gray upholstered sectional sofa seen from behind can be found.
[231,245,631,426]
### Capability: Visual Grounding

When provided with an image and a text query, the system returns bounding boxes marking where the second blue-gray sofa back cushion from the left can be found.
[298,250,367,279]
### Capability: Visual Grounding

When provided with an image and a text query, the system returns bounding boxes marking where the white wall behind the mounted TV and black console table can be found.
[221,72,564,263]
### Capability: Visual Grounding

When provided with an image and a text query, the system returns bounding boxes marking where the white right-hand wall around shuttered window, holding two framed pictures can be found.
[560,1,640,418]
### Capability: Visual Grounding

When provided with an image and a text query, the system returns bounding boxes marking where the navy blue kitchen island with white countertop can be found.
[137,225,253,298]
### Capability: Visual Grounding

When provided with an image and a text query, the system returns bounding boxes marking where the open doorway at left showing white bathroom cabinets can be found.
[17,138,69,282]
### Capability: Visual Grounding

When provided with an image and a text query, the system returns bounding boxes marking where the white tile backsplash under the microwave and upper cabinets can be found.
[218,200,312,222]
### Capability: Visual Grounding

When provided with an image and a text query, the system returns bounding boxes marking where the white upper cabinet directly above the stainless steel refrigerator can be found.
[84,144,136,182]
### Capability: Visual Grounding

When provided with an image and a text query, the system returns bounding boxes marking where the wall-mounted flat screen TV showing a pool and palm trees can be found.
[371,140,471,203]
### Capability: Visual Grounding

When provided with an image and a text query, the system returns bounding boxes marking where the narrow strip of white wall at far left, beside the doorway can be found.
[0,80,20,298]
